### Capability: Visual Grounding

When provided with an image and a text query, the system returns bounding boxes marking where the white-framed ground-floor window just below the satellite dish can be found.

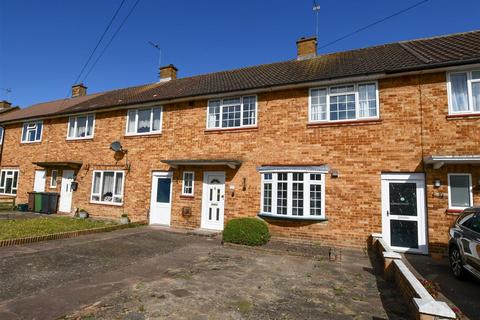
[90,170,124,205]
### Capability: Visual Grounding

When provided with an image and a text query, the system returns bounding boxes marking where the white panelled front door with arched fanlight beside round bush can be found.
[201,172,225,230]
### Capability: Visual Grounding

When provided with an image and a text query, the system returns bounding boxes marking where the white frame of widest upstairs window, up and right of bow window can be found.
[308,80,380,124]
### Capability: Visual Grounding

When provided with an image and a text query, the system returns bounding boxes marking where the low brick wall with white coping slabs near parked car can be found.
[372,234,456,320]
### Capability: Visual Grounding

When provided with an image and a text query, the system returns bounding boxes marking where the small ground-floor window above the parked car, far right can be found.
[448,173,473,209]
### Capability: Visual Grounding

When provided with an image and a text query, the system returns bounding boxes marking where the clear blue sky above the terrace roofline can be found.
[0,0,480,107]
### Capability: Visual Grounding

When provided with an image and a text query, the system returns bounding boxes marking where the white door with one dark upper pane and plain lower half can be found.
[150,172,172,226]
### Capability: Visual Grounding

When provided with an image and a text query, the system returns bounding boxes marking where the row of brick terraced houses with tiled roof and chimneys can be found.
[0,31,480,253]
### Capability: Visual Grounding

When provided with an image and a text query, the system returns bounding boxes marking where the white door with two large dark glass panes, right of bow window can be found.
[382,173,428,254]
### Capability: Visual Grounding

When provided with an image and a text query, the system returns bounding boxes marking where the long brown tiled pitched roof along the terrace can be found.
[0,30,480,122]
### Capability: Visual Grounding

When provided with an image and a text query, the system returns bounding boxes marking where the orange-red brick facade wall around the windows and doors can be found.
[1,73,480,251]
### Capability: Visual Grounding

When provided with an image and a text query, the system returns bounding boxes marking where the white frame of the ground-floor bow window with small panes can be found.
[260,169,326,220]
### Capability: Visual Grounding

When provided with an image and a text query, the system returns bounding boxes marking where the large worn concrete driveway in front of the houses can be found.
[0,227,406,320]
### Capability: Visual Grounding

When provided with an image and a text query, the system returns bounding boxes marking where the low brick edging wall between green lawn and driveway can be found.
[0,222,147,247]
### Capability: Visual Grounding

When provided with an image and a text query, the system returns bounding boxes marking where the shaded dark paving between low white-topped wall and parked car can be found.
[405,254,480,320]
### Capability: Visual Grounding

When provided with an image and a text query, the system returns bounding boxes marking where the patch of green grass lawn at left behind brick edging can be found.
[0,217,115,240]
